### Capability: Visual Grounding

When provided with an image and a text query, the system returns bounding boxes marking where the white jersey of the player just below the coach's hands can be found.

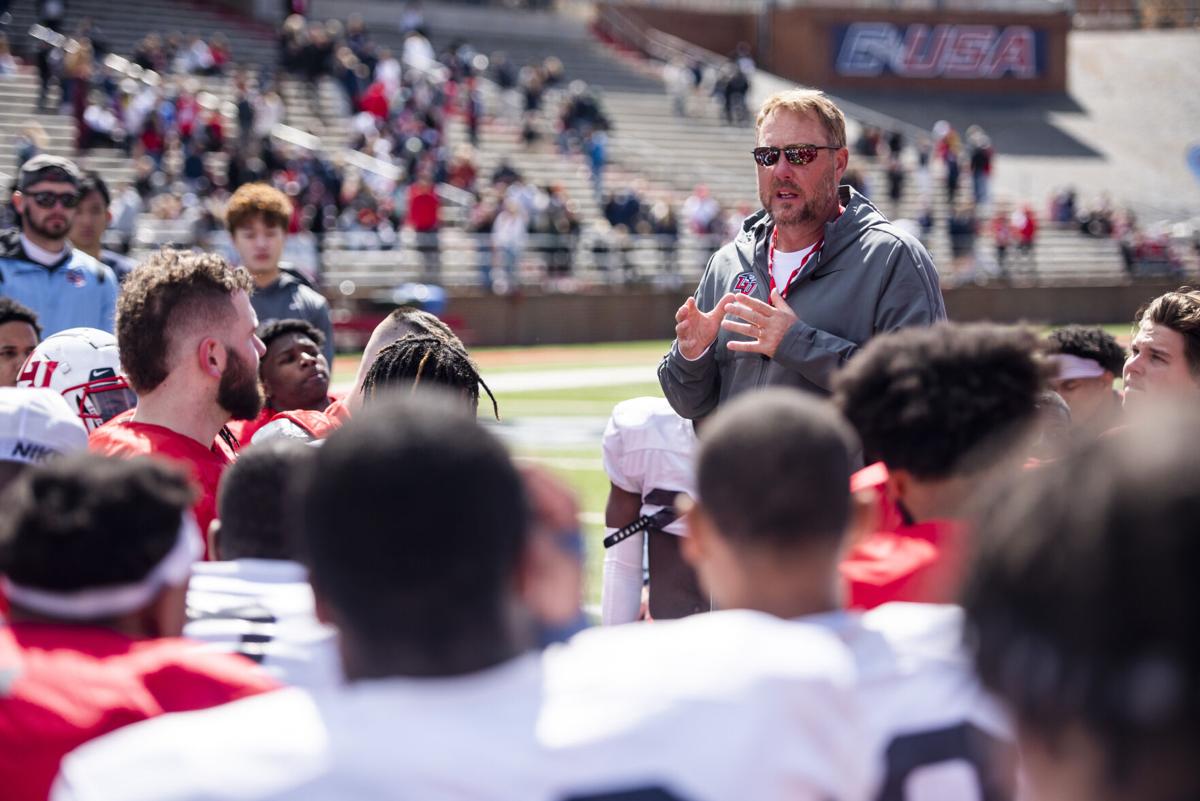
[604,398,696,535]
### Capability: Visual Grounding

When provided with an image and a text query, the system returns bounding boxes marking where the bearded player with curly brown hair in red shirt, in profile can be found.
[89,248,264,551]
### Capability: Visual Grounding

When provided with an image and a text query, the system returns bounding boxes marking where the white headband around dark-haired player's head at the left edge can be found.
[0,510,204,620]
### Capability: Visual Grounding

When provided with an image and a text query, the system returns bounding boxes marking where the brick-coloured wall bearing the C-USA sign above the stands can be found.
[608,4,1070,94]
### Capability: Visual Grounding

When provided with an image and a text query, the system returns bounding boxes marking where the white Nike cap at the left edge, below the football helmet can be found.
[0,386,88,464]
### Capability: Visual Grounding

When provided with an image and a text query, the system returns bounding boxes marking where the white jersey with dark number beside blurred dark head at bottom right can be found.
[800,603,1014,801]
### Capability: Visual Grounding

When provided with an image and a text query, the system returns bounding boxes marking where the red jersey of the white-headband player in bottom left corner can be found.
[0,624,277,801]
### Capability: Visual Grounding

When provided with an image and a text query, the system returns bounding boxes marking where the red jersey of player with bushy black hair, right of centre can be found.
[839,520,967,609]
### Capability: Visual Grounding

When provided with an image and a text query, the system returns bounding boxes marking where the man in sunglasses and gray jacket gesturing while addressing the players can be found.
[659,89,946,418]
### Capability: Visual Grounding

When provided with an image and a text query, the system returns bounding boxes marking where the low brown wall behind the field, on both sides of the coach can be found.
[445,282,1177,345]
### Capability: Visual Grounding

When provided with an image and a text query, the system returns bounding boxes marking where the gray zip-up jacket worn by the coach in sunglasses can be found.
[659,186,946,420]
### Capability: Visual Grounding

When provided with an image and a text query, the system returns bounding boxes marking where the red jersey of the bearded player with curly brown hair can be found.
[88,410,238,559]
